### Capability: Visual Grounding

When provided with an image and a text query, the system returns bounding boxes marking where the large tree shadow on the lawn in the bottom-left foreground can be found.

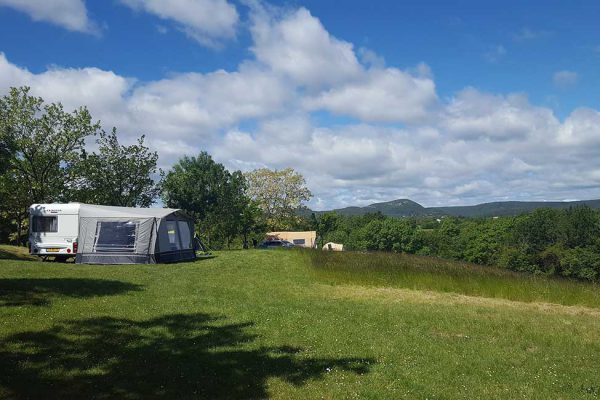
[0,314,373,399]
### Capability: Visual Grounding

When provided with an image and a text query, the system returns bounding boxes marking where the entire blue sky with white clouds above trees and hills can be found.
[0,0,600,210]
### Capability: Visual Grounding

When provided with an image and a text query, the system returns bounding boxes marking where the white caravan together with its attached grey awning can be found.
[29,203,196,264]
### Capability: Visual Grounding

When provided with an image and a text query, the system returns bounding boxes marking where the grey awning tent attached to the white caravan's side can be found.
[75,204,196,264]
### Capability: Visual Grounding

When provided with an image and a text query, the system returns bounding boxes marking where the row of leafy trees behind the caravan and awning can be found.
[0,87,311,248]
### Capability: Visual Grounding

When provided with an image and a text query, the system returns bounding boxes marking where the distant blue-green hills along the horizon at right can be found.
[303,199,600,217]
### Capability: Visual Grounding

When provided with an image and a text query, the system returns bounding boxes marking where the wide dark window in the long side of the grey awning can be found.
[94,221,139,253]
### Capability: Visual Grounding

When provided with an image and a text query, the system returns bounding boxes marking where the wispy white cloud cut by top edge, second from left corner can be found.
[121,0,239,47]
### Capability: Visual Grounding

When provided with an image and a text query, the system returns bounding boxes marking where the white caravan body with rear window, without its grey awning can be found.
[29,203,80,260]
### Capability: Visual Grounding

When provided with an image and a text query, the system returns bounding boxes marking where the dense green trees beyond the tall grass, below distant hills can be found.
[311,206,600,282]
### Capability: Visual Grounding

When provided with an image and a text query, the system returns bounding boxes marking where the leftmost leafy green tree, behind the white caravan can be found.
[0,87,100,244]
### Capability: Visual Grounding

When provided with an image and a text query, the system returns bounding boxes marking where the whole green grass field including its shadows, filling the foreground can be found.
[0,246,600,399]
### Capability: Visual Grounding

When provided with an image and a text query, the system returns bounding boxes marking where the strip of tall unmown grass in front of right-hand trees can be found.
[306,252,600,308]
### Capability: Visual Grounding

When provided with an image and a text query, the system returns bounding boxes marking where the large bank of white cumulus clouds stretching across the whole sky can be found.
[0,5,600,209]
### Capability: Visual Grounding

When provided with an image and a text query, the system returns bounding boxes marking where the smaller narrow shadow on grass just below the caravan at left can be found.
[0,278,142,307]
